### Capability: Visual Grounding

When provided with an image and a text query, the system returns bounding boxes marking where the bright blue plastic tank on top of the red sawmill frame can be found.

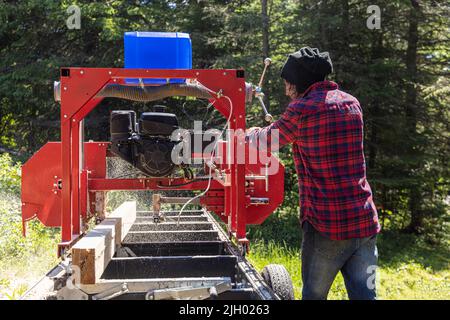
[124,31,192,84]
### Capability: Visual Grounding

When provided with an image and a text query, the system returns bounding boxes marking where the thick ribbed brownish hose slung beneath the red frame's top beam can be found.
[97,83,213,102]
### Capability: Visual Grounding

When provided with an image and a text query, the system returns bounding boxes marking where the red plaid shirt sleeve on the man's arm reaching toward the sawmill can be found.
[246,105,300,151]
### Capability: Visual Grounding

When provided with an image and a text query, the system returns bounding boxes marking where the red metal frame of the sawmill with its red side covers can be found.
[22,68,284,255]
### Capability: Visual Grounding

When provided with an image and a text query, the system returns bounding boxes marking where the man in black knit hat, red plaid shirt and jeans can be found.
[247,47,380,299]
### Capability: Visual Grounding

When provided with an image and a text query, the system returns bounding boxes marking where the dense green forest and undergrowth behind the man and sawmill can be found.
[0,0,450,299]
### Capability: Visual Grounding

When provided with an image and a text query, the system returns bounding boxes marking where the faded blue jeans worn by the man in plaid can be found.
[302,221,378,300]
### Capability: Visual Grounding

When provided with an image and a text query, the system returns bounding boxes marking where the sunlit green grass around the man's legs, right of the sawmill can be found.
[249,231,450,300]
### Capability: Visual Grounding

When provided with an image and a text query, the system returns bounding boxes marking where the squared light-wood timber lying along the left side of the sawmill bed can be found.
[72,202,136,284]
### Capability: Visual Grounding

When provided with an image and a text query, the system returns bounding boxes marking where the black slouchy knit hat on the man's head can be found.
[281,47,333,93]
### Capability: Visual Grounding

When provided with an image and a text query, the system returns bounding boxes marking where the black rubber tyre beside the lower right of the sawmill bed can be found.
[261,264,294,300]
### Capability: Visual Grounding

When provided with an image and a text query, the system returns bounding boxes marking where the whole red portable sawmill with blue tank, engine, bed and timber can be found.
[22,32,293,300]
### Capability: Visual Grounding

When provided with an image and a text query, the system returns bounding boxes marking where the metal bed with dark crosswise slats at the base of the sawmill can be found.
[23,210,279,300]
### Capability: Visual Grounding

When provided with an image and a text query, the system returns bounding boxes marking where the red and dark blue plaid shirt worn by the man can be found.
[247,81,380,240]
